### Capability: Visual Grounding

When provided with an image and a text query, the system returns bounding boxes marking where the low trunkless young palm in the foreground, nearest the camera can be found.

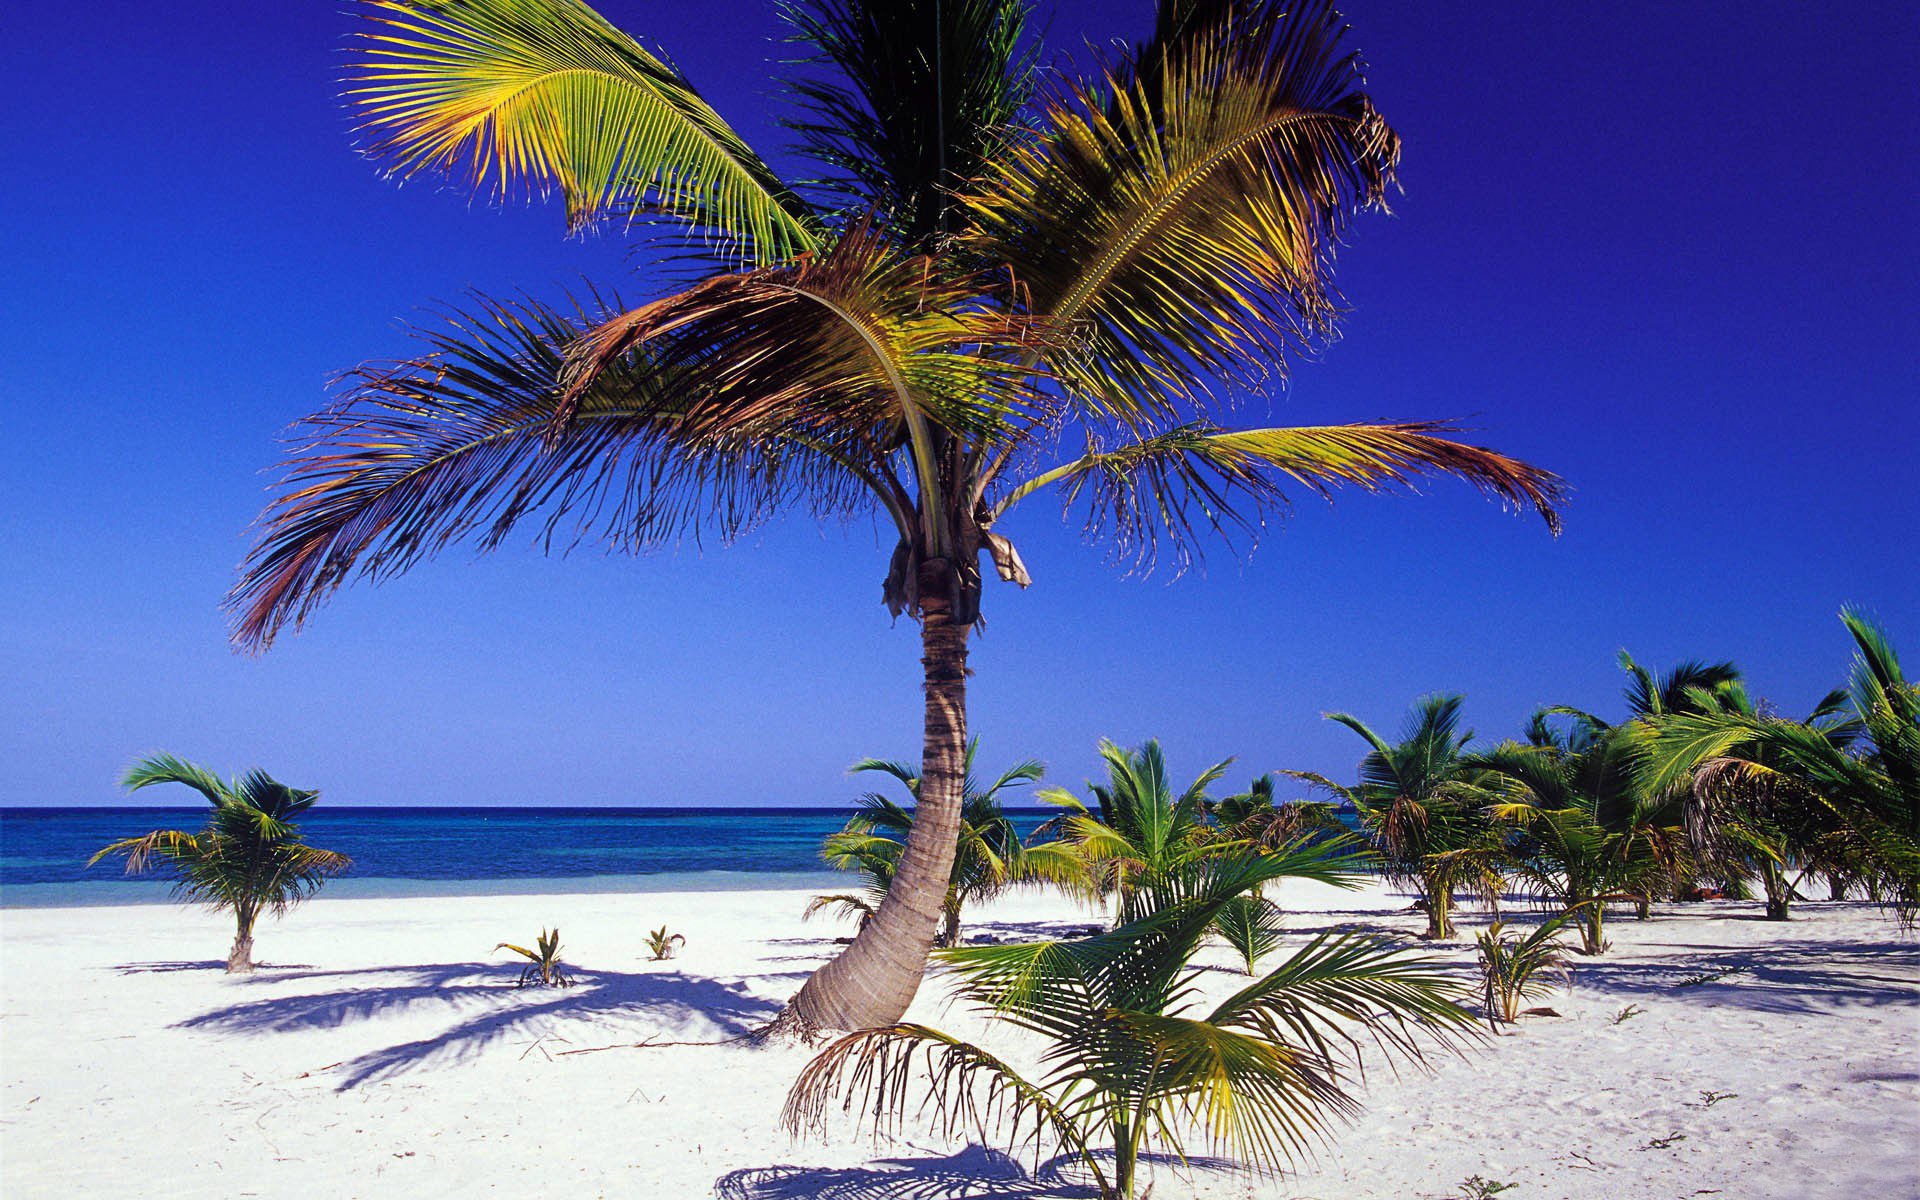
[785,847,1471,1200]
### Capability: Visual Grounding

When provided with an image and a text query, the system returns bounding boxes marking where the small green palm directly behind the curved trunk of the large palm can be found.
[806,737,1073,947]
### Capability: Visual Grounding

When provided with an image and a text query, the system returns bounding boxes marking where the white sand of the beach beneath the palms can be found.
[0,883,1920,1200]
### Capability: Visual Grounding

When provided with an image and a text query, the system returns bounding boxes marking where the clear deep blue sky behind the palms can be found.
[0,0,1920,804]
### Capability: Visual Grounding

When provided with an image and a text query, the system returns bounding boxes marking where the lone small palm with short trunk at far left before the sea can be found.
[86,755,353,973]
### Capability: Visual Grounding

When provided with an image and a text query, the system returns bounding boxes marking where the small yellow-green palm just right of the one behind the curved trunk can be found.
[1033,739,1244,924]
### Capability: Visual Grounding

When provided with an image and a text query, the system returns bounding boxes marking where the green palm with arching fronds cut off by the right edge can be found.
[1636,609,1920,920]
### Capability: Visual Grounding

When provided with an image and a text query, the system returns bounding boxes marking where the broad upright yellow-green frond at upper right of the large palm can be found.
[966,4,1400,424]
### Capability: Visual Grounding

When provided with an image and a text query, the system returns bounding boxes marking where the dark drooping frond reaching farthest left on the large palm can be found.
[227,286,917,651]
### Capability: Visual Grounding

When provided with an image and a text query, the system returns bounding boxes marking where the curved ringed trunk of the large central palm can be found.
[776,572,968,1033]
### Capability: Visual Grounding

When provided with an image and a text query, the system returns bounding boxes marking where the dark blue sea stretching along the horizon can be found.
[0,806,1056,906]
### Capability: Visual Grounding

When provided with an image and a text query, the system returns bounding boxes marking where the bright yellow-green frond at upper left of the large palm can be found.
[348,0,818,253]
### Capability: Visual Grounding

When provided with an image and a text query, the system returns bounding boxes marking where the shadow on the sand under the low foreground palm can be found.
[714,1144,1240,1200]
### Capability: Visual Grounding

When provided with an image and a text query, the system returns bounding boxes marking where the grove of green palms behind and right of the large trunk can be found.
[814,611,1920,936]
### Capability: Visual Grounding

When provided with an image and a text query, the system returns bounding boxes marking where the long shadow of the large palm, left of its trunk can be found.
[175,962,779,1091]
